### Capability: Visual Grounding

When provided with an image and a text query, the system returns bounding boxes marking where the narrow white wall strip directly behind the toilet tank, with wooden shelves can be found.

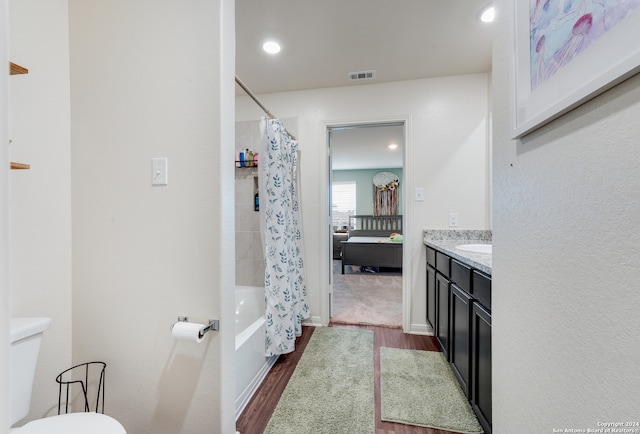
[9,0,71,421]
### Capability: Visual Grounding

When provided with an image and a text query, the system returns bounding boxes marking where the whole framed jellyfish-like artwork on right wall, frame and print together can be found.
[511,0,640,139]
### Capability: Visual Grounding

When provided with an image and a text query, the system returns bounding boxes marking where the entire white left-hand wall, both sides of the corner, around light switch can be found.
[0,0,235,433]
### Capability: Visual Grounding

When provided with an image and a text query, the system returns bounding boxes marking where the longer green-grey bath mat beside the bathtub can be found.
[264,327,375,434]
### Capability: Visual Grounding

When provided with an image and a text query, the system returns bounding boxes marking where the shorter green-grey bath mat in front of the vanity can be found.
[380,347,483,433]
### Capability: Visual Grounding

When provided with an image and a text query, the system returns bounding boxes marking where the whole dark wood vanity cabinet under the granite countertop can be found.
[426,246,491,434]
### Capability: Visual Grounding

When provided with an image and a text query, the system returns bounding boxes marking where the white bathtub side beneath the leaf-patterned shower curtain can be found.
[236,286,278,419]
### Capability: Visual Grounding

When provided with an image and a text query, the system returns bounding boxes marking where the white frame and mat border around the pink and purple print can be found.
[511,0,640,139]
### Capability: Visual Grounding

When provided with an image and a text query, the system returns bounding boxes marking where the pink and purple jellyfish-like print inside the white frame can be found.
[529,0,640,90]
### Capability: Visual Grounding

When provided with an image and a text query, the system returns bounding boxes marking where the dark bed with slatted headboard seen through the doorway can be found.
[341,215,402,274]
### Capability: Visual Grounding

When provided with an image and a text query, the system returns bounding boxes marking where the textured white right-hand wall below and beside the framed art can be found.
[492,0,640,433]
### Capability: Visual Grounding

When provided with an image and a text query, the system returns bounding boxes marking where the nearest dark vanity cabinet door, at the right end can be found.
[471,302,492,434]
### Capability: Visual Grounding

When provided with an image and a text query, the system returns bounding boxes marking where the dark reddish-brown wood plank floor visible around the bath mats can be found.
[236,324,455,434]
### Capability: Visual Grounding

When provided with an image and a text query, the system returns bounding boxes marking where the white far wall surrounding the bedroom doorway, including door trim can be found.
[236,74,489,331]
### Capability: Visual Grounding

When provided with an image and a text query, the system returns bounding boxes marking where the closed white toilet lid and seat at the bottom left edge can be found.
[9,412,127,434]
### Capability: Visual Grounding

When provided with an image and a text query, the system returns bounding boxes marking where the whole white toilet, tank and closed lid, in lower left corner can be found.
[9,318,126,434]
